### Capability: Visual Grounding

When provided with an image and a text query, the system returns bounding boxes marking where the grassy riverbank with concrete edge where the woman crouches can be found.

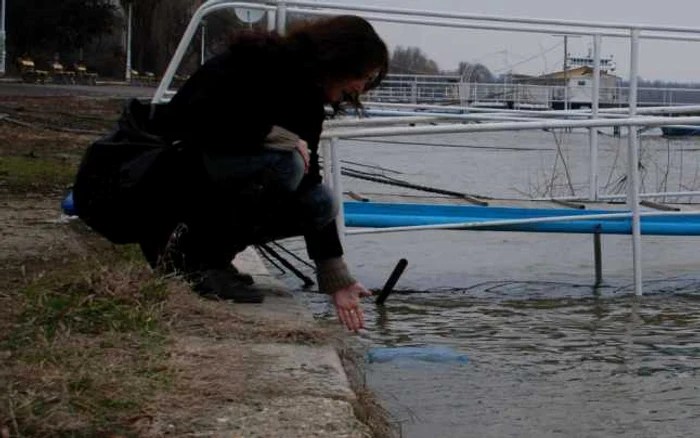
[0,96,389,437]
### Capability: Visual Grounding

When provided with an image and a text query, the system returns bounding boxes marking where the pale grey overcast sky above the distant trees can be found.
[324,0,700,82]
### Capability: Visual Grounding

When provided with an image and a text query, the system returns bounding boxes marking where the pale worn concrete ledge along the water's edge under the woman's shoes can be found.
[180,248,371,438]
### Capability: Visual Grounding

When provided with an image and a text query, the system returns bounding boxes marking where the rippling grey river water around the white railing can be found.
[285,132,700,437]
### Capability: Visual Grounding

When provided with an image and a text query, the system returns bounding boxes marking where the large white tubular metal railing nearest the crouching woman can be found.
[153,0,700,295]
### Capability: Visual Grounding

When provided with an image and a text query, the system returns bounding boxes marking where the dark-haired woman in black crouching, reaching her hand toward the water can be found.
[140,16,388,330]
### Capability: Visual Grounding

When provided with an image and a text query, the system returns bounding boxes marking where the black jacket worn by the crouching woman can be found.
[161,38,342,259]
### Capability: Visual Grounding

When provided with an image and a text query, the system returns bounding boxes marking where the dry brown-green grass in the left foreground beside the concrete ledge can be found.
[0,247,173,437]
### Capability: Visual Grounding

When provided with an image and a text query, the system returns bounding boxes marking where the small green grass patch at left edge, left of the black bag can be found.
[0,156,78,192]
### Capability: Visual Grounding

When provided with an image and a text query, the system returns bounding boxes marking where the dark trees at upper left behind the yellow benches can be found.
[6,0,252,77]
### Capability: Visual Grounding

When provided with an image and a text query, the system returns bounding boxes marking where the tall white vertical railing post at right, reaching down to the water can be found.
[627,28,642,295]
